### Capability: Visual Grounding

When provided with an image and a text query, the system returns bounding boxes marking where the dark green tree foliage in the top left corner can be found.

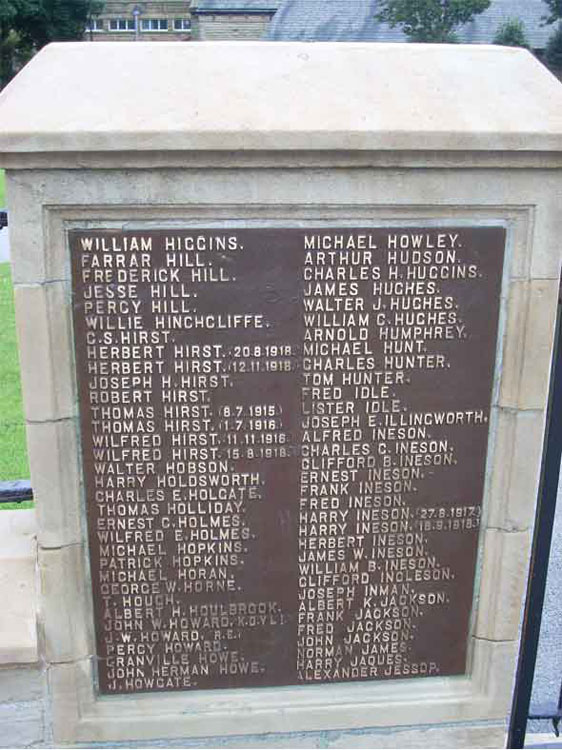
[0,0,103,87]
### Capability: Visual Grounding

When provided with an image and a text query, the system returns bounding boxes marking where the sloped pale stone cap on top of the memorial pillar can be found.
[0,42,562,157]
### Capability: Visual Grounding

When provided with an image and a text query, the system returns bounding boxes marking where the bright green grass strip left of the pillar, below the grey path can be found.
[0,262,29,482]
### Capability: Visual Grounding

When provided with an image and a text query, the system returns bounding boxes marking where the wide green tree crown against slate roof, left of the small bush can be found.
[376,0,490,42]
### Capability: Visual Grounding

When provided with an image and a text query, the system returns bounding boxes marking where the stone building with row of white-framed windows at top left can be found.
[85,0,191,42]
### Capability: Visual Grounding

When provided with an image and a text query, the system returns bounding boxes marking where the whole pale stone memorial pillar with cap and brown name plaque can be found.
[0,43,562,747]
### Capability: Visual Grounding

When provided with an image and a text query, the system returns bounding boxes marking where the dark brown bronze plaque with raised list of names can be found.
[70,227,505,693]
